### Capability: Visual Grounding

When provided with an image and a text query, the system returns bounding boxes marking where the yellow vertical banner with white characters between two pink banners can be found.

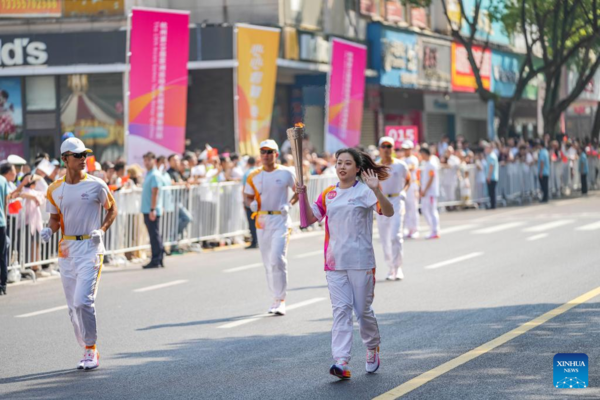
[237,25,280,156]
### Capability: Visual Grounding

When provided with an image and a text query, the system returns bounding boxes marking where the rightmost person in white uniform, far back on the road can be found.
[420,147,440,239]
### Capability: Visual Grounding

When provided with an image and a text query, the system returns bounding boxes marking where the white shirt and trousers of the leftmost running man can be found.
[46,174,115,360]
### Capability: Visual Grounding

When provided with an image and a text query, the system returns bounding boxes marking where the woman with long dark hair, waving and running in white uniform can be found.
[296,148,394,379]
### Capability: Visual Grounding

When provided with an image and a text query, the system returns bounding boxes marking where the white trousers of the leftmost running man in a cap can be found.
[58,254,104,347]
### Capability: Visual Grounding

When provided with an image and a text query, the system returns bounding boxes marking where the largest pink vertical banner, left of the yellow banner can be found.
[127,8,190,165]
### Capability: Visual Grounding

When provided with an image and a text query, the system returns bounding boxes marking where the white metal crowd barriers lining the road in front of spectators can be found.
[7,158,600,279]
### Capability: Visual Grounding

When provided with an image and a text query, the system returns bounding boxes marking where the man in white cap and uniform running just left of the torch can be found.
[244,140,297,315]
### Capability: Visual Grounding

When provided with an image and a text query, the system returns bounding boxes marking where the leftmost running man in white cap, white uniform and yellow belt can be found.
[40,138,117,369]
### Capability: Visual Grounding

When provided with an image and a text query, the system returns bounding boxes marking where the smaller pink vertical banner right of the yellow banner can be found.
[325,39,367,153]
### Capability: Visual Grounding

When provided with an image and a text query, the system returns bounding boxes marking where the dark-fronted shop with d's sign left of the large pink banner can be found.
[0,31,125,160]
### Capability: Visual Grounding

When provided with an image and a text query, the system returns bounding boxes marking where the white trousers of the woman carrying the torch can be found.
[326,269,380,362]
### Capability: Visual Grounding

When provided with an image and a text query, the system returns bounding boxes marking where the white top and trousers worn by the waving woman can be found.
[312,181,381,372]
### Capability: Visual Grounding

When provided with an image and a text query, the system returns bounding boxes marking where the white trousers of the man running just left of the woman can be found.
[256,228,290,300]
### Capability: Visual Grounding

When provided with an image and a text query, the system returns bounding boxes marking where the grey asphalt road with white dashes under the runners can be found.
[0,194,600,399]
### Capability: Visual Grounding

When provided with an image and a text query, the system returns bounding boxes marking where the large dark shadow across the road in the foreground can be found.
[0,303,600,400]
